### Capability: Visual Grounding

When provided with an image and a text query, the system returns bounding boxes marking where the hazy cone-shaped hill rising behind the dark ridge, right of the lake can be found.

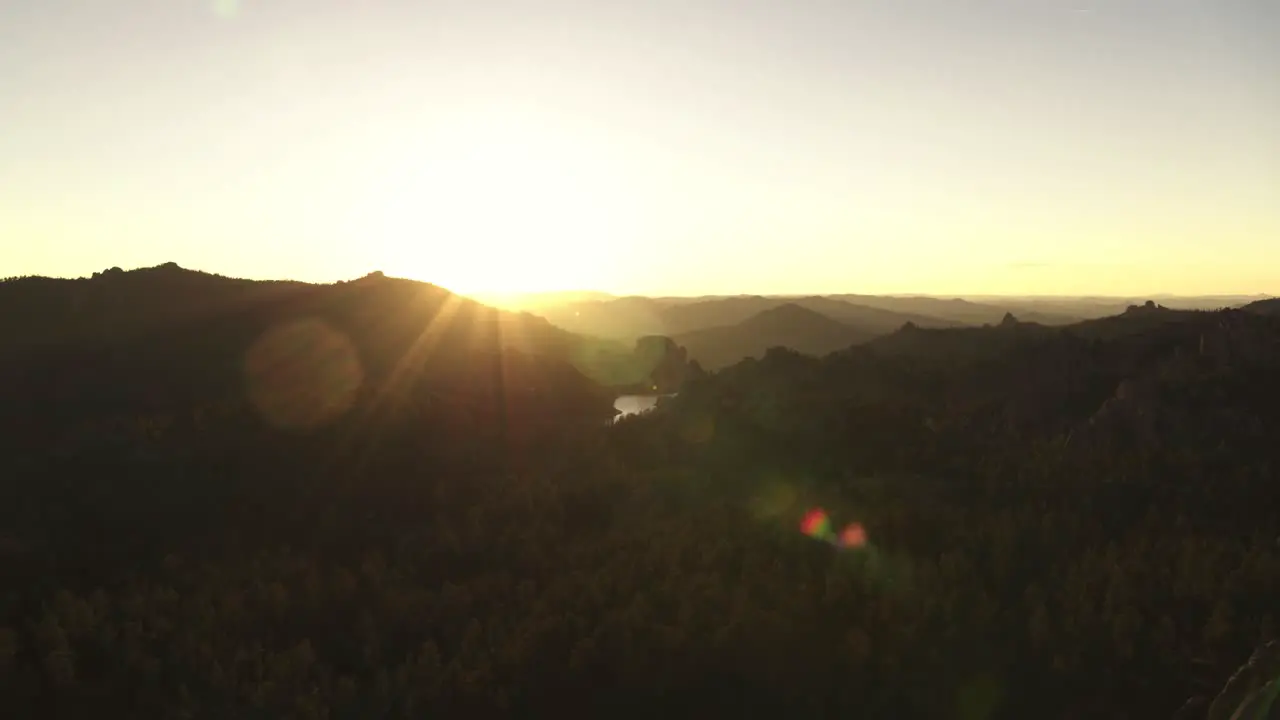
[673,302,872,370]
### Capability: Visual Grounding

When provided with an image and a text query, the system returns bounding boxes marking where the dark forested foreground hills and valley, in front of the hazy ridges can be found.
[0,266,1280,720]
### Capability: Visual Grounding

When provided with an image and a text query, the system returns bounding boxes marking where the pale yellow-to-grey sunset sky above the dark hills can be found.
[0,0,1280,295]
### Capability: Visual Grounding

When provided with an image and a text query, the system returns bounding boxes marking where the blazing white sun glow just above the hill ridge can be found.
[367,113,622,293]
